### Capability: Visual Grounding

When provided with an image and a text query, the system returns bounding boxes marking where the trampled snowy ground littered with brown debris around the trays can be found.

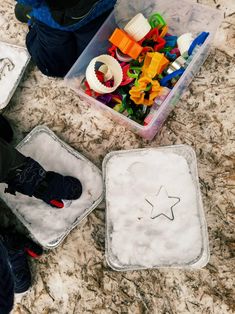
[0,0,235,314]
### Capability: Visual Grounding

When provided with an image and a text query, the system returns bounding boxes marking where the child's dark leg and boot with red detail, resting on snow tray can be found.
[0,138,82,207]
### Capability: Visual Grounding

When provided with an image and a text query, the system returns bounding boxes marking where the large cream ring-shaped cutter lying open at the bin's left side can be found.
[86,55,123,94]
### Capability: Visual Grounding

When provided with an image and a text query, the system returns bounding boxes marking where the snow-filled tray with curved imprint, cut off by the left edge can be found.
[0,41,30,109]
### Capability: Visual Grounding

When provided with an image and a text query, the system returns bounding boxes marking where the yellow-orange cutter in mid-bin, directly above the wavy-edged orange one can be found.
[142,52,170,78]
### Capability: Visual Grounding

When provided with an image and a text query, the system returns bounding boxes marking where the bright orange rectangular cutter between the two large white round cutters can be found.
[109,28,143,59]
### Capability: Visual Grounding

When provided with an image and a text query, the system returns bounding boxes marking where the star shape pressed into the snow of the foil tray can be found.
[145,186,180,220]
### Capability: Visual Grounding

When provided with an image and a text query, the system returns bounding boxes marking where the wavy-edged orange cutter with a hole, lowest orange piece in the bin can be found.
[129,76,162,106]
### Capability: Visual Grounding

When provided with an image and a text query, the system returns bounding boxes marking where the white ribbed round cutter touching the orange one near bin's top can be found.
[124,13,151,41]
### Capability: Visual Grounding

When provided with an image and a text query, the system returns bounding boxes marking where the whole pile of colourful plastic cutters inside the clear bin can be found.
[83,13,209,125]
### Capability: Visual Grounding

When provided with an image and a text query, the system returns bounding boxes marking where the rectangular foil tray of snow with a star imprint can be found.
[103,145,209,270]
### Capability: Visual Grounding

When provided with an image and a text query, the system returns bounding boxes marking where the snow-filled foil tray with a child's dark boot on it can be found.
[0,126,103,248]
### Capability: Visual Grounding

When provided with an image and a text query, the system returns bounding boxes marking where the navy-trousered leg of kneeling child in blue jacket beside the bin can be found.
[26,21,78,77]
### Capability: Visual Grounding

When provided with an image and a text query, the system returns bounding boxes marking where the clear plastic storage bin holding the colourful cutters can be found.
[65,0,222,140]
